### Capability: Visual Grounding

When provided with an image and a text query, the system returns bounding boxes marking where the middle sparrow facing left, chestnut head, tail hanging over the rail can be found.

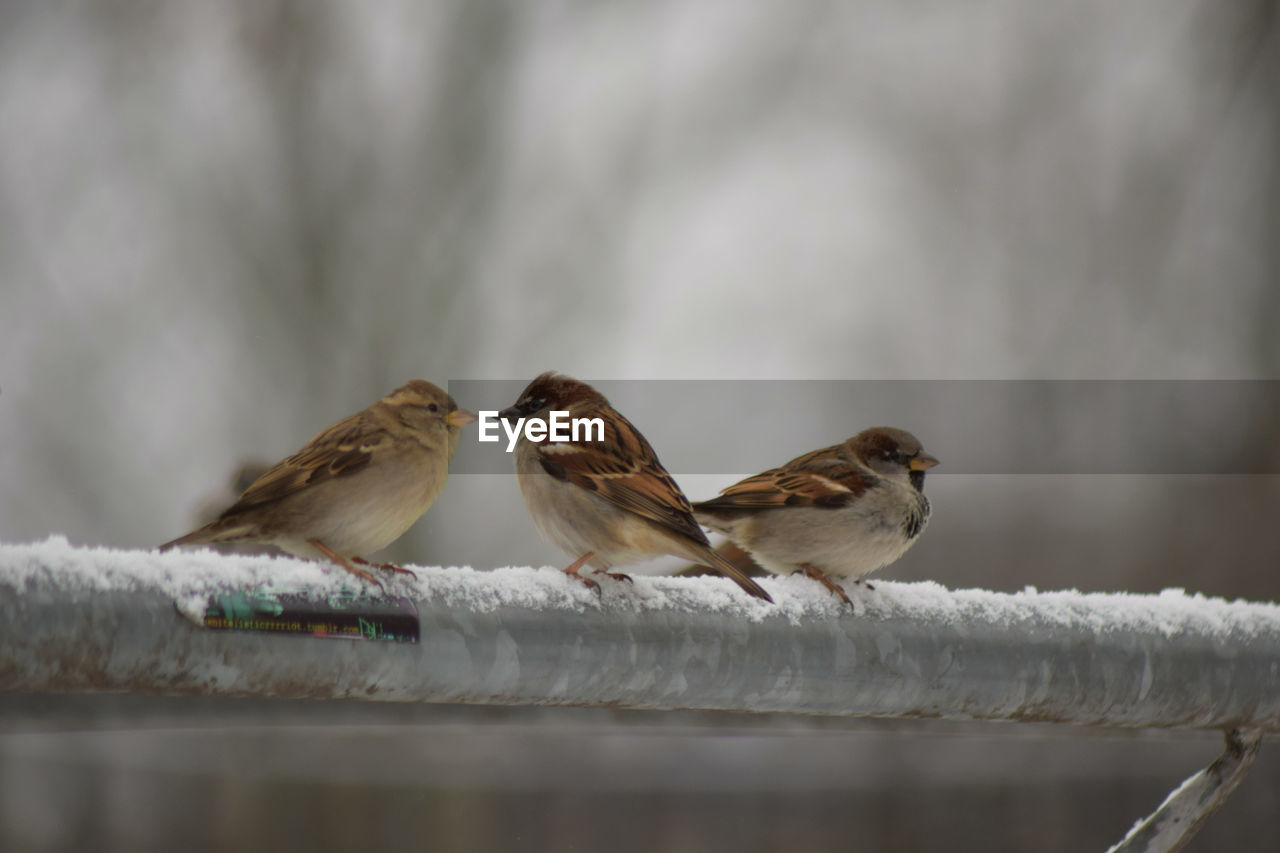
[498,373,773,602]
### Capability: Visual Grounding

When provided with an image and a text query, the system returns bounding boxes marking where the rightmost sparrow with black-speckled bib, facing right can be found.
[694,427,938,603]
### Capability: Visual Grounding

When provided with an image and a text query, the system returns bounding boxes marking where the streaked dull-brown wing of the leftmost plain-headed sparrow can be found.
[220,412,390,519]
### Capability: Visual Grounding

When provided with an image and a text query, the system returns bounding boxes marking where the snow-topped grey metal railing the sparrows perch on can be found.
[0,537,1280,850]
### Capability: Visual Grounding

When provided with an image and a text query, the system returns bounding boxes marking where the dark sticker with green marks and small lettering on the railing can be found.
[192,590,419,643]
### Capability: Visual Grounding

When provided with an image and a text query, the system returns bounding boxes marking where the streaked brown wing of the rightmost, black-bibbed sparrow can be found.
[698,444,877,511]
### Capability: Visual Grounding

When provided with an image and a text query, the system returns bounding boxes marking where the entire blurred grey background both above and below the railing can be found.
[0,0,1280,850]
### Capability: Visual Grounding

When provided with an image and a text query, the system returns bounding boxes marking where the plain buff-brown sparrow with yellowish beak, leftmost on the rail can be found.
[160,379,476,585]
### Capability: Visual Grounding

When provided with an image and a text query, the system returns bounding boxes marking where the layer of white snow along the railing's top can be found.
[0,535,1280,638]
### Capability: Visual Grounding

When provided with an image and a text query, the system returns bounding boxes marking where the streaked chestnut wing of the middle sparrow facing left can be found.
[538,415,707,544]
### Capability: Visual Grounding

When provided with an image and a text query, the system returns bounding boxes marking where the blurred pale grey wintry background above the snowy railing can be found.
[0,0,1280,597]
